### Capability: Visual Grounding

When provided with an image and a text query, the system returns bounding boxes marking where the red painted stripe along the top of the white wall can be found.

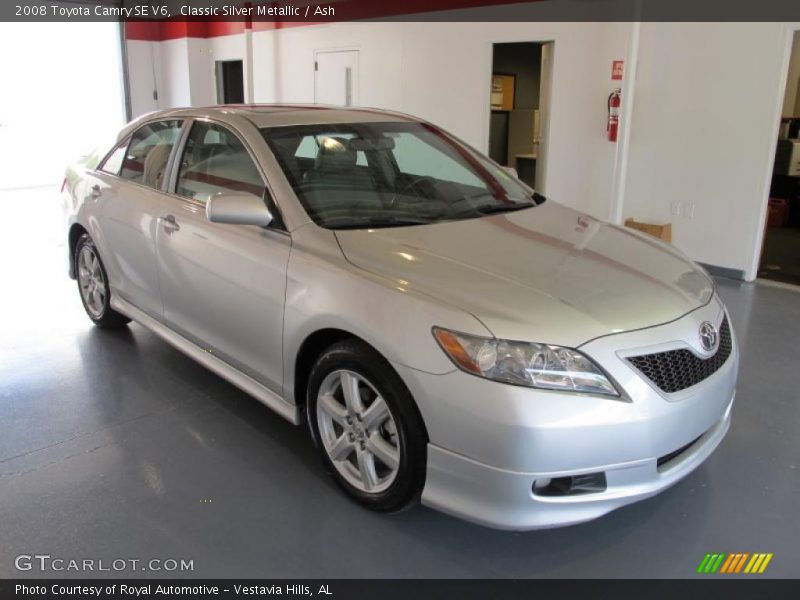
[125,0,542,42]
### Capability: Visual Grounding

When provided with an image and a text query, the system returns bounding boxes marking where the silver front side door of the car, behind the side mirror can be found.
[157,120,291,393]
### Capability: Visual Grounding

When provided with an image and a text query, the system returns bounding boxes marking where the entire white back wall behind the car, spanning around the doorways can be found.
[123,22,800,279]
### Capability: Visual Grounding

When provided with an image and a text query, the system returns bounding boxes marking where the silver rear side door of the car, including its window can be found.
[91,119,183,318]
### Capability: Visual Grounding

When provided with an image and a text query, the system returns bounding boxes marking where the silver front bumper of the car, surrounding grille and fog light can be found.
[395,299,738,530]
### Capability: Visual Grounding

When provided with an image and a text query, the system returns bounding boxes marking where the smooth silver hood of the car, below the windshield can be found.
[336,201,713,347]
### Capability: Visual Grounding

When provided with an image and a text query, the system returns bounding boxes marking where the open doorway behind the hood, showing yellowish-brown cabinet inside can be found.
[489,42,553,193]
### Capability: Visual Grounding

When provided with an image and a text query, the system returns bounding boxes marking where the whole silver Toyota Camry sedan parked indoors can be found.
[63,105,738,529]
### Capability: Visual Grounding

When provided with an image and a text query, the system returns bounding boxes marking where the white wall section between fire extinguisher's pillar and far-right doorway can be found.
[623,23,792,279]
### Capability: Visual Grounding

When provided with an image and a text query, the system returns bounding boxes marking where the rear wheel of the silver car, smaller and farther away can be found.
[75,233,130,329]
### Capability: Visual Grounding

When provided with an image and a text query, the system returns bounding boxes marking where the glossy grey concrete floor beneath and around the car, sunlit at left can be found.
[0,189,800,578]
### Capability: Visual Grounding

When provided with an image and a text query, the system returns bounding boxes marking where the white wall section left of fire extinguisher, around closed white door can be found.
[253,23,629,219]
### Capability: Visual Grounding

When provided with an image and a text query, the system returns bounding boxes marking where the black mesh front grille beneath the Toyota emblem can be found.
[628,317,732,394]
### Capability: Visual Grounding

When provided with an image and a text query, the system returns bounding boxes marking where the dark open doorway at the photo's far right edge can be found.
[758,31,800,285]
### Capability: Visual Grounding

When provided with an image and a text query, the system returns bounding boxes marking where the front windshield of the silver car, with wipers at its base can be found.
[261,122,541,229]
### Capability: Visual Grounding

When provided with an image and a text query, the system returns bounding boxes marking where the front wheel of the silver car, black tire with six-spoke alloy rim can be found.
[306,340,428,512]
